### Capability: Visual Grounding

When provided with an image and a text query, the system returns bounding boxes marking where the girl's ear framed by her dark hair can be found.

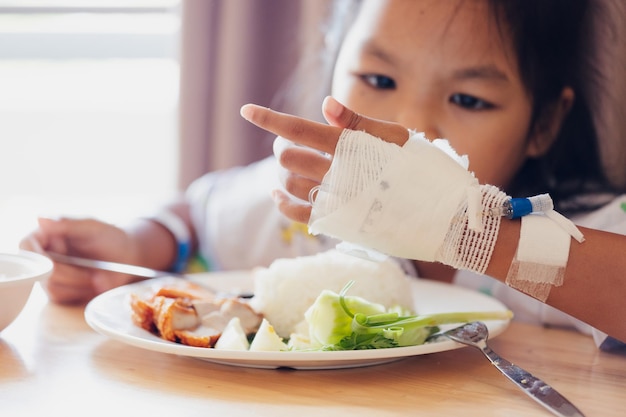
[526,87,574,158]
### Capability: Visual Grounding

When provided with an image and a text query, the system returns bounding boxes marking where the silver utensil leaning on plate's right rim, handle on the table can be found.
[442,321,584,417]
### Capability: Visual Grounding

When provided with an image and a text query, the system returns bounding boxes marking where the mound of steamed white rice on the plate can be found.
[250,250,414,338]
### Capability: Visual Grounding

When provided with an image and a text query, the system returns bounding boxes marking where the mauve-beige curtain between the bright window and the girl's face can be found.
[178,0,328,189]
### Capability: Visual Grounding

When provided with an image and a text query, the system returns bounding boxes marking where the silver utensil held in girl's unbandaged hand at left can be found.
[44,252,253,298]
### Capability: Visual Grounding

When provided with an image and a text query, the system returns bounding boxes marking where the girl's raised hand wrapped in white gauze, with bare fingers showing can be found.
[242,99,506,270]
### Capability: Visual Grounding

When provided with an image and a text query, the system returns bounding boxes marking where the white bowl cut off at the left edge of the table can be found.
[0,251,53,331]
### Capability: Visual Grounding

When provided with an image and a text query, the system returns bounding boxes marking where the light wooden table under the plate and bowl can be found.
[0,286,626,417]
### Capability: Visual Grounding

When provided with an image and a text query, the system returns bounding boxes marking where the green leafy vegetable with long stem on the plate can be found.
[305,281,512,350]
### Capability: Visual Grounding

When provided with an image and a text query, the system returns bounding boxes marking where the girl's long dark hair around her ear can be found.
[489,0,618,214]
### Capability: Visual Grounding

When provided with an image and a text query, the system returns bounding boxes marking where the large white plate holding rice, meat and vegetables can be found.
[85,272,509,369]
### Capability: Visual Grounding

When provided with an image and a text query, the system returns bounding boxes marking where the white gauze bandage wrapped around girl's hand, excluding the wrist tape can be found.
[309,130,508,273]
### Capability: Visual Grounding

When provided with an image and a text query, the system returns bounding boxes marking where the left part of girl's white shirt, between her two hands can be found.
[186,157,337,270]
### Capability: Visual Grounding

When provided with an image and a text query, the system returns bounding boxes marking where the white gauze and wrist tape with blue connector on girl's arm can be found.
[309,130,584,301]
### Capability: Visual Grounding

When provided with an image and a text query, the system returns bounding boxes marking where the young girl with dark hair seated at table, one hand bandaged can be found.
[25,0,626,344]
